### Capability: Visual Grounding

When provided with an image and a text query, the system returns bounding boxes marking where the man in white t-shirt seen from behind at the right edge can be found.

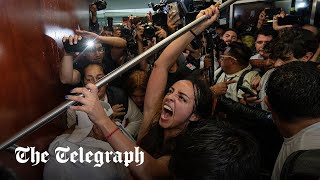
[265,61,320,180]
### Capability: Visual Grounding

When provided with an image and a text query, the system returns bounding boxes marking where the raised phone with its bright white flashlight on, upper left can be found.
[63,38,94,53]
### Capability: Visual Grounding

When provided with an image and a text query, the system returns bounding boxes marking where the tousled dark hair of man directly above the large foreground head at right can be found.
[272,27,319,60]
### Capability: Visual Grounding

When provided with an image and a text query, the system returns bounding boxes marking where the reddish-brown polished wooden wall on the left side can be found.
[0,0,89,179]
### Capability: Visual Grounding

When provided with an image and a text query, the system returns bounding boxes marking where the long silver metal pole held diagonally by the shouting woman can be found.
[0,0,236,150]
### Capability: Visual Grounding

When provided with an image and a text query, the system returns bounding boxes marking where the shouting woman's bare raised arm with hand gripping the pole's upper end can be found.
[142,4,219,140]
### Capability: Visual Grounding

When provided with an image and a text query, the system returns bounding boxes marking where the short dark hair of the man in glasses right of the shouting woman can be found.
[228,42,251,65]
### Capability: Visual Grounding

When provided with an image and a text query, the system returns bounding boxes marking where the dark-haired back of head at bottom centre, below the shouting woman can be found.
[169,122,259,180]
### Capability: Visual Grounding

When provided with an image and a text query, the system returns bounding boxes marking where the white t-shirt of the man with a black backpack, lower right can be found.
[271,122,320,180]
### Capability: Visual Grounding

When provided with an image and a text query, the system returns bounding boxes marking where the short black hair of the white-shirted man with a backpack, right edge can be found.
[266,61,320,122]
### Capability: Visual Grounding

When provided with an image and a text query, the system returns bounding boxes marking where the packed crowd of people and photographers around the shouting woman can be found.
[40,4,320,180]
